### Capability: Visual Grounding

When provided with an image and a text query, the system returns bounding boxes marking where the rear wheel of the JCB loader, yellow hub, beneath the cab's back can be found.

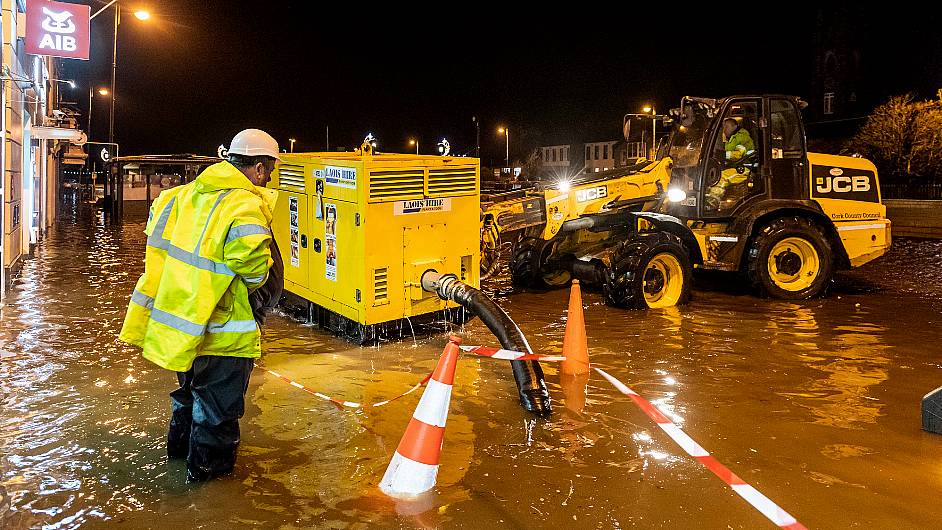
[748,217,834,300]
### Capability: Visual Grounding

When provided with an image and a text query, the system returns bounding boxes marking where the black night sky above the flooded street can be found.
[61,0,942,163]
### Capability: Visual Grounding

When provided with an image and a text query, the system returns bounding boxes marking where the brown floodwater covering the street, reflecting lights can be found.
[0,200,942,529]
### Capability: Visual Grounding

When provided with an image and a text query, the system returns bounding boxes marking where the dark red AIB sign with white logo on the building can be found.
[26,0,91,61]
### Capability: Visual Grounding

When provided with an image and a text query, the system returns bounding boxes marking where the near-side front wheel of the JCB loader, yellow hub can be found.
[603,232,693,309]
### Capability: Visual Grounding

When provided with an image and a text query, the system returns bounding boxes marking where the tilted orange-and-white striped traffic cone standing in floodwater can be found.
[379,335,461,497]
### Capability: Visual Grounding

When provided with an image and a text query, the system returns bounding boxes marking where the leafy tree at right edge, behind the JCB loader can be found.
[850,94,942,179]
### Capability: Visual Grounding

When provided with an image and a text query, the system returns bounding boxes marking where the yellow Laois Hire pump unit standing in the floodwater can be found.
[269,146,480,343]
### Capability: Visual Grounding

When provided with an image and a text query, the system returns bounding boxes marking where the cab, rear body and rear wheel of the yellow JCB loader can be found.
[664,95,890,299]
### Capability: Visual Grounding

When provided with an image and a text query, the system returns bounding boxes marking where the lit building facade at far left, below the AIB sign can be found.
[0,0,63,300]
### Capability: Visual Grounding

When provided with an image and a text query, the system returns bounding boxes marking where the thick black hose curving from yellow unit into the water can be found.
[422,271,552,416]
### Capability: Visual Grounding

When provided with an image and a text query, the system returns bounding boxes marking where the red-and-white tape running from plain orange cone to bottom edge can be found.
[593,367,805,530]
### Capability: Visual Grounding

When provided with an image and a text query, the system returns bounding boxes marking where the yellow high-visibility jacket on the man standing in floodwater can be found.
[119,162,277,372]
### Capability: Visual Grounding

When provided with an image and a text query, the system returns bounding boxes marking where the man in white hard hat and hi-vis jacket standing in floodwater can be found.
[119,129,281,482]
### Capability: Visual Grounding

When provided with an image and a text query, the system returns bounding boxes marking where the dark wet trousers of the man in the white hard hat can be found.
[167,355,253,480]
